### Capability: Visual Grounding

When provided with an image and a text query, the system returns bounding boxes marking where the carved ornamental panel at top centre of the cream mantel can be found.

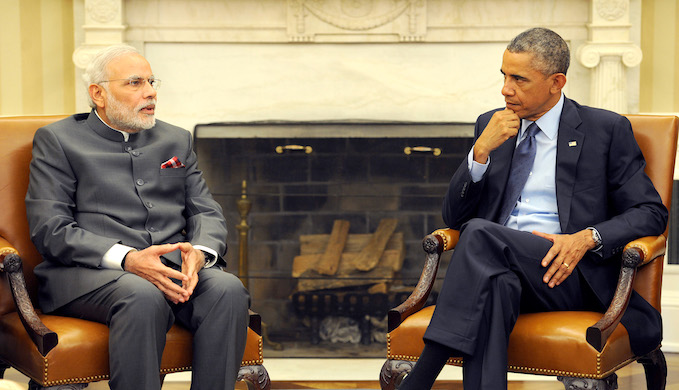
[288,0,427,42]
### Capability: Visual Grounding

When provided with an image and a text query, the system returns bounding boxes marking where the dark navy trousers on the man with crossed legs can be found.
[424,219,593,389]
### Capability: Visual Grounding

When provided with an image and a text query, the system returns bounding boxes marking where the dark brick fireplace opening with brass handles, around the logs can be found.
[194,121,473,354]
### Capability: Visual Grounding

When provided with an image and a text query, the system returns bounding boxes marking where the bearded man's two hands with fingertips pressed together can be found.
[125,242,205,304]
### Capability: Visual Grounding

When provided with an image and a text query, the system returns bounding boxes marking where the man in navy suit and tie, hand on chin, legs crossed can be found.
[400,28,668,389]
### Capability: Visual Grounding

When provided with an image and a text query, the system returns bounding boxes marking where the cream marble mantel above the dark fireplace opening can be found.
[73,0,642,133]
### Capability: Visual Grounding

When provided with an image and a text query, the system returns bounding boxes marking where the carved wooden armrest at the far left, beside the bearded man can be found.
[0,244,58,356]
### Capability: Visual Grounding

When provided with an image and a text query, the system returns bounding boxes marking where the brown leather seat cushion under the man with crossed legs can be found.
[387,306,635,379]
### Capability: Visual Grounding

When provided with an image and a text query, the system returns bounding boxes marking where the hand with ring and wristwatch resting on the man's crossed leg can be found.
[533,229,596,288]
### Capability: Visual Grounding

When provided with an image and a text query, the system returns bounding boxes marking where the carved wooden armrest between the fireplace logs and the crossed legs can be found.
[388,229,460,332]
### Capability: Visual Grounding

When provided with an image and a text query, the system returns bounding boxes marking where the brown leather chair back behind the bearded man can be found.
[0,116,64,315]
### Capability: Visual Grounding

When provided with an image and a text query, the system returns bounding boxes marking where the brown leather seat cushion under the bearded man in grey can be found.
[0,312,263,387]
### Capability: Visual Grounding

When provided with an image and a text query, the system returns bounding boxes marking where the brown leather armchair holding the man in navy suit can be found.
[380,115,679,390]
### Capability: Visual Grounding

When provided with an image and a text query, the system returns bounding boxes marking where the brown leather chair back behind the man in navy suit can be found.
[626,115,679,311]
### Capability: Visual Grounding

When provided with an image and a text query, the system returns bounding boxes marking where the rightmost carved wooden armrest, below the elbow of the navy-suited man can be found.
[587,235,666,352]
